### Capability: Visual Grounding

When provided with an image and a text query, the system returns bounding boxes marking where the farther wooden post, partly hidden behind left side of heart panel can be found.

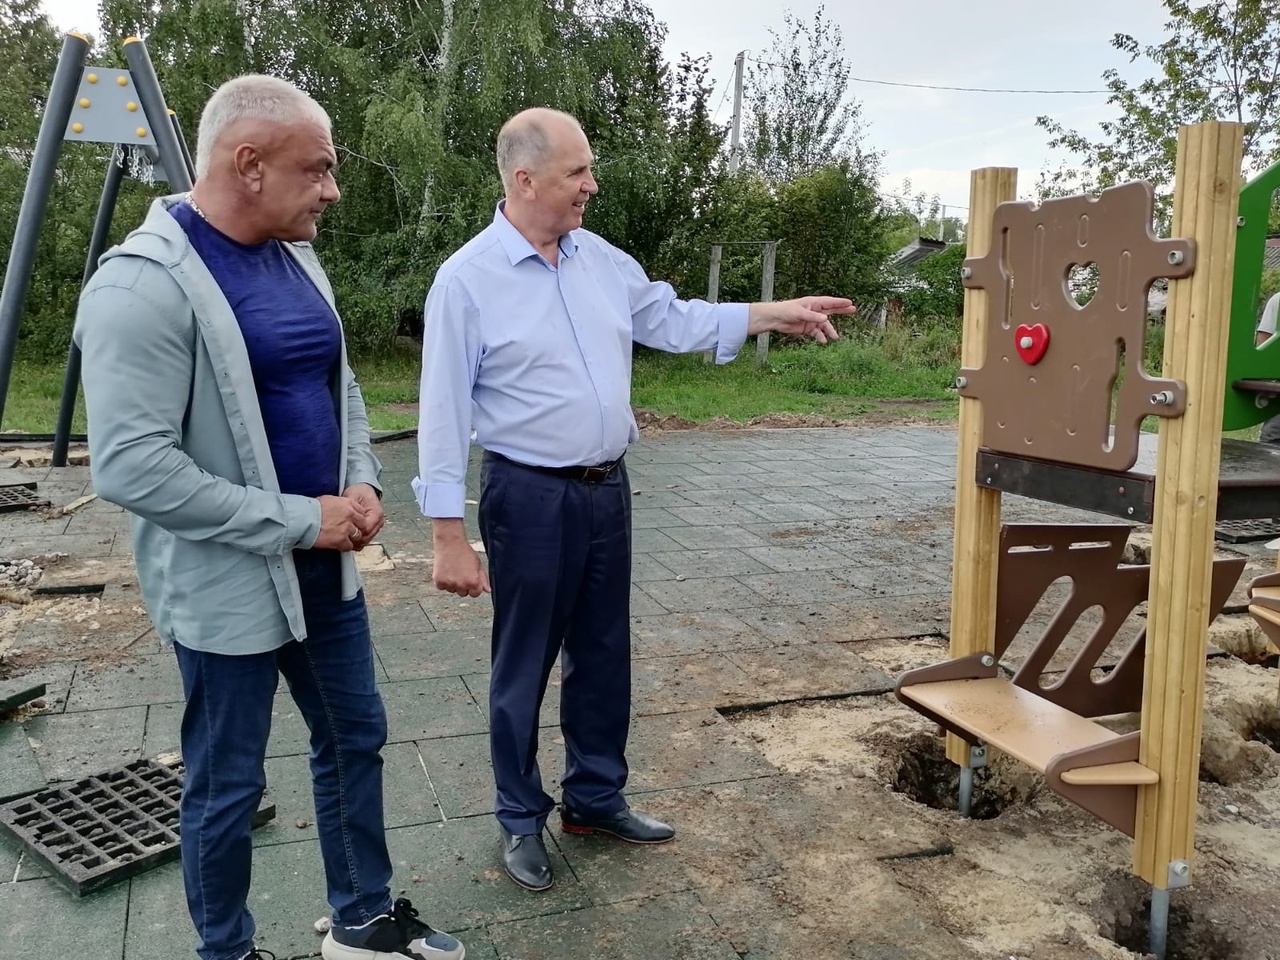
[947,166,1018,767]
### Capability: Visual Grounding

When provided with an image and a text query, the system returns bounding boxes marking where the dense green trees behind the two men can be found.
[0,0,888,376]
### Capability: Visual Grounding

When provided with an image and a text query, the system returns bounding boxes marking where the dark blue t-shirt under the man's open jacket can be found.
[169,202,342,497]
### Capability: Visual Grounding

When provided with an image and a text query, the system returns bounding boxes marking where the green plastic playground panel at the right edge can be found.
[1222,164,1280,430]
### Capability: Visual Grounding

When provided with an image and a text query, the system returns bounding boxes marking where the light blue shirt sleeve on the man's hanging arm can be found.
[413,278,481,518]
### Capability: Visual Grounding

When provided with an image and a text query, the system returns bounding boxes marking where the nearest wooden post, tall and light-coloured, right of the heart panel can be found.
[1134,122,1243,890]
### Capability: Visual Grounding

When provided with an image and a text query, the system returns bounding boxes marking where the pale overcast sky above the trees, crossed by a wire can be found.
[45,0,1165,207]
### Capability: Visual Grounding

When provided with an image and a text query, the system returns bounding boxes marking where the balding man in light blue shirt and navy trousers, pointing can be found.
[413,109,854,890]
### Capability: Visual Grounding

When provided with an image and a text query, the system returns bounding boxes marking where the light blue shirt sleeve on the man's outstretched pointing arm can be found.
[609,247,750,364]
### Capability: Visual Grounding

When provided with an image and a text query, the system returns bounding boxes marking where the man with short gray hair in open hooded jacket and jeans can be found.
[76,76,465,960]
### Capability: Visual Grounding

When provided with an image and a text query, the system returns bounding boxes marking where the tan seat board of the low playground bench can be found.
[899,677,1157,786]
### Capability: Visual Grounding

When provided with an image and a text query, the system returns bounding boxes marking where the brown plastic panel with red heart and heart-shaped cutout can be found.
[960,183,1196,470]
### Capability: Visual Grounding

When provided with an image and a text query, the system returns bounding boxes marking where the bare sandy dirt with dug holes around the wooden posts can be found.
[721,640,1280,960]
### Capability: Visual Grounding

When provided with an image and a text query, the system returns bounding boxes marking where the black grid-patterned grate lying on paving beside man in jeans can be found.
[0,760,275,897]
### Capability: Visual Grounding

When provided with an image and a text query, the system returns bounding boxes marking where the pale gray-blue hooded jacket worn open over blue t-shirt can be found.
[74,196,381,654]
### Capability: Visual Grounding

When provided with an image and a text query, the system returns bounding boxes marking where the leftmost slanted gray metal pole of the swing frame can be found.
[0,33,88,422]
